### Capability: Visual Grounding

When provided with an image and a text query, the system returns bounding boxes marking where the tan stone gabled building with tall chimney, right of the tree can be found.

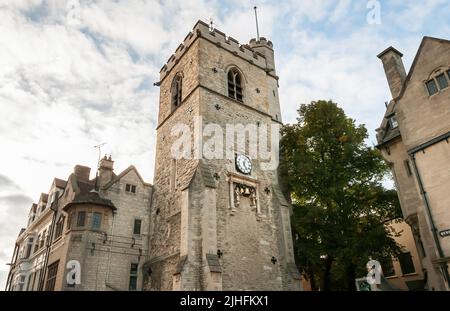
[377,37,450,290]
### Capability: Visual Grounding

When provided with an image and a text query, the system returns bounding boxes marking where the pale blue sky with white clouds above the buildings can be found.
[0,0,450,289]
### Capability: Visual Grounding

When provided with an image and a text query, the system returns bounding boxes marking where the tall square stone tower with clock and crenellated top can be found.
[144,21,301,290]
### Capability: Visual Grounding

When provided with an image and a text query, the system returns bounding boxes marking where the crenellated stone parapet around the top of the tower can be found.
[160,21,273,81]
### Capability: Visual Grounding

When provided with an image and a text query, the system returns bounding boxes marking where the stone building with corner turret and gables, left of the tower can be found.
[6,156,152,290]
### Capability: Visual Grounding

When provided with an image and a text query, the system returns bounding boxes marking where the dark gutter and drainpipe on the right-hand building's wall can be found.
[408,132,450,287]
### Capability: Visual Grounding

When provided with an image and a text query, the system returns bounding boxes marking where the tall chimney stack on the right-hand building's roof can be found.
[378,46,406,99]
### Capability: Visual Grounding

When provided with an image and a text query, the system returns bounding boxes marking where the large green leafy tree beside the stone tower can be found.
[280,101,401,290]
